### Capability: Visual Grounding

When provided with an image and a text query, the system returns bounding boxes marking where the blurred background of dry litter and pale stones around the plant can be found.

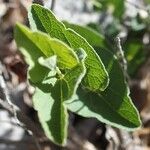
[0,0,150,150]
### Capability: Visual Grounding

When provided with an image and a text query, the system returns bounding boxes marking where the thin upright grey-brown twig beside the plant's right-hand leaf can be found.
[115,37,129,80]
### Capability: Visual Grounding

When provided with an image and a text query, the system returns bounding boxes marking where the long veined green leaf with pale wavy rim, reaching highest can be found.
[29,4,108,91]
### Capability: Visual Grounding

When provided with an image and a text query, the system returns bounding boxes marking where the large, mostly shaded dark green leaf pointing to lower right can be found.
[66,50,141,130]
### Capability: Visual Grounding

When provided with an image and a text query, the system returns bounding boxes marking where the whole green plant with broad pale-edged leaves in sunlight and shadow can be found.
[15,4,141,145]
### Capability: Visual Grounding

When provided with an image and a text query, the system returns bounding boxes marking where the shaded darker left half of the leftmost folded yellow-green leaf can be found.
[14,25,48,82]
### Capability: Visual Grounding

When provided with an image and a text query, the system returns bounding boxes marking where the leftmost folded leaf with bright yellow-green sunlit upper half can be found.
[15,24,79,82]
